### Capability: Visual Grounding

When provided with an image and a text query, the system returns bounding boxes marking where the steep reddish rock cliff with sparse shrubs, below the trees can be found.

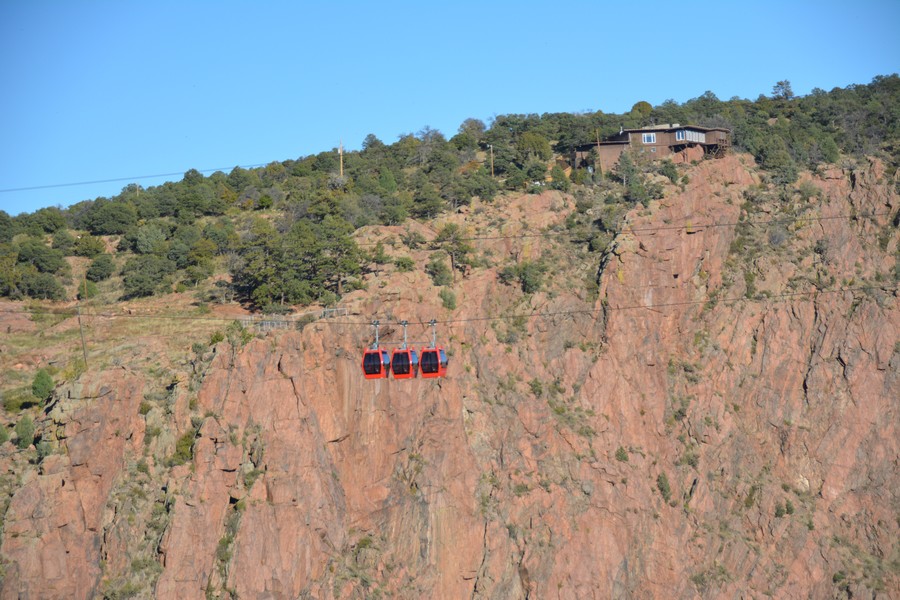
[0,153,900,598]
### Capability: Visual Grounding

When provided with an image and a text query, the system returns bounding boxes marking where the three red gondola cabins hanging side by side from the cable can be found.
[362,319,449,379]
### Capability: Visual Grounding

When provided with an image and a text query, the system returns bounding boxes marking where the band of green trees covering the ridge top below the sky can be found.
[0,75,900,310]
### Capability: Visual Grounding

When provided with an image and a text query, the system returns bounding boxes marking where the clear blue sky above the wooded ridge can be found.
[0,0,900,215]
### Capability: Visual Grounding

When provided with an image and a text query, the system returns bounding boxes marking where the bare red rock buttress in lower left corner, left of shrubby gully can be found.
[0,370,144,598]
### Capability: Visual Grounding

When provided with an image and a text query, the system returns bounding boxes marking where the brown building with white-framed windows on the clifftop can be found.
[573,123,730,172]
